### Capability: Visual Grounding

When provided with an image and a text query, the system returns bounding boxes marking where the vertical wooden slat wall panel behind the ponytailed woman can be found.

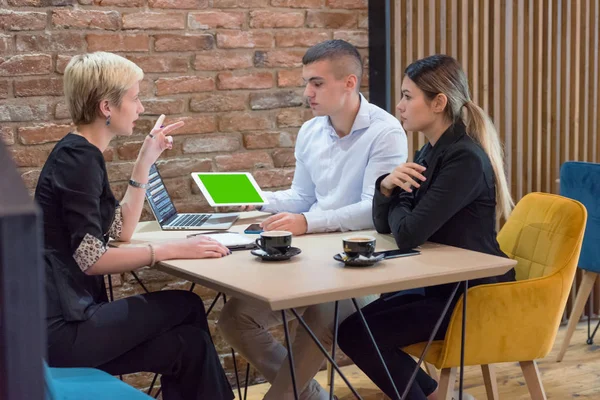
[392,0,600,314]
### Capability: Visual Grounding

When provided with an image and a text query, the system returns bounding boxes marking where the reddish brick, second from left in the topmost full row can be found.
[52,8,121,31]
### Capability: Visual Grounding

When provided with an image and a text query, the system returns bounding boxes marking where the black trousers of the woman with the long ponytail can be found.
[338,294,453,400]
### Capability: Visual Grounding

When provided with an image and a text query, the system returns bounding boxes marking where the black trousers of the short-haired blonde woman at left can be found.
[48,290,234,400]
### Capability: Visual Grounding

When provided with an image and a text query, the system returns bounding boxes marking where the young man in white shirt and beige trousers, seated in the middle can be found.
[218,40,408,400]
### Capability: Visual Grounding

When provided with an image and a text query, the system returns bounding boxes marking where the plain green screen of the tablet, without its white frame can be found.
[197,173,264,204]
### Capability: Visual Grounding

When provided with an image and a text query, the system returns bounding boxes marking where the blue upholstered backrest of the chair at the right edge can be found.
[560,161,600,273]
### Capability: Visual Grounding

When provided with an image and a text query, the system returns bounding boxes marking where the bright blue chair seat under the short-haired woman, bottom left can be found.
[44,362,154,400]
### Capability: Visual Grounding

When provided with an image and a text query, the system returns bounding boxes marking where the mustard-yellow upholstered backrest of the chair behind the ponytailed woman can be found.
[498,193,587,284]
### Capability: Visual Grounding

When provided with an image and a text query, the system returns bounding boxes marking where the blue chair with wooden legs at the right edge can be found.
[556,162,600,361]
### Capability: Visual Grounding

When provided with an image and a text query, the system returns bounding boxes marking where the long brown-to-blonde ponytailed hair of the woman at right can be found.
[404,55,514,222]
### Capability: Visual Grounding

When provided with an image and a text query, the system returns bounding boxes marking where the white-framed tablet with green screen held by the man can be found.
[192,172,268,207]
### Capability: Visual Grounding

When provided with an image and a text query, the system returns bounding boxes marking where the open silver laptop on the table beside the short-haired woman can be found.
[146,164,239,231]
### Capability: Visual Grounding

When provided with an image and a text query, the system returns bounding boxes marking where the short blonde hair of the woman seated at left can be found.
[64,51,144,126]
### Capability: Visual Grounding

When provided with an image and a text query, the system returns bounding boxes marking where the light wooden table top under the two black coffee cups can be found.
[115,212,516,311]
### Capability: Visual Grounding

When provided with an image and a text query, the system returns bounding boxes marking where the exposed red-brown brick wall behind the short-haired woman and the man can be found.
[0,0,368,392]
